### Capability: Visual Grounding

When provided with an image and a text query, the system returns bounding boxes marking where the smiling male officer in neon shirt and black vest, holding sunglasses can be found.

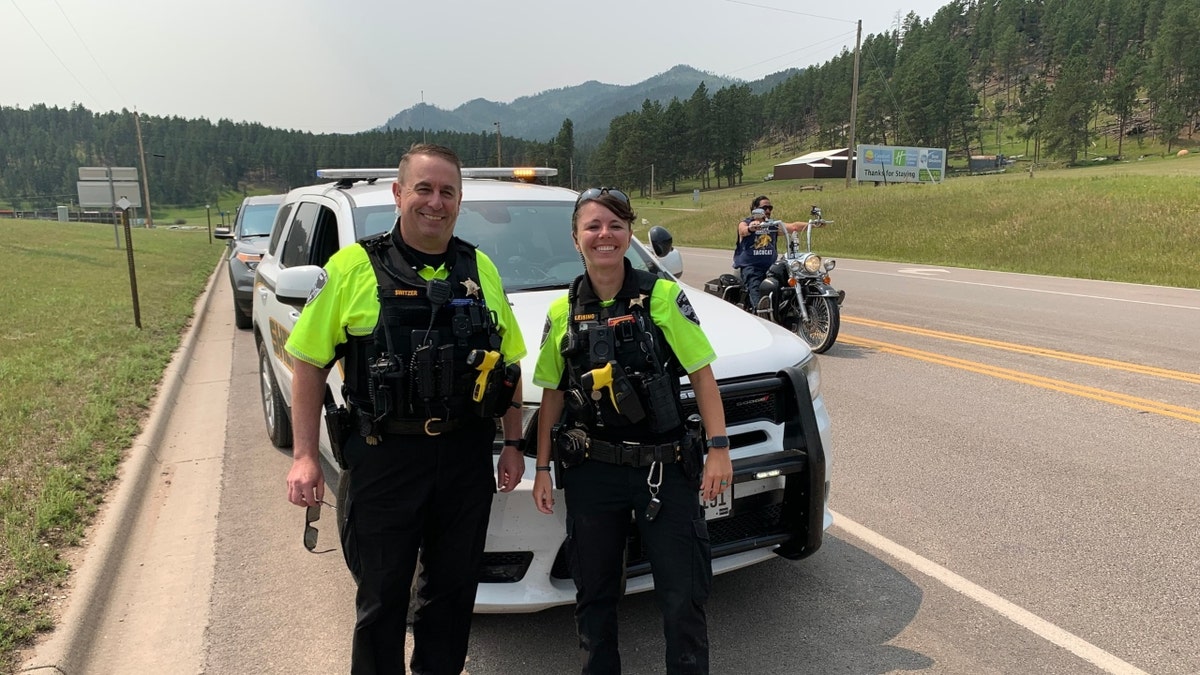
[287,144,526,675]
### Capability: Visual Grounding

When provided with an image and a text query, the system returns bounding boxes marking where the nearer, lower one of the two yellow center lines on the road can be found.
[838,334,1200,424]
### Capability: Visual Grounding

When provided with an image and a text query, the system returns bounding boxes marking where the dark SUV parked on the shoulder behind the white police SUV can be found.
[212,195,283,329]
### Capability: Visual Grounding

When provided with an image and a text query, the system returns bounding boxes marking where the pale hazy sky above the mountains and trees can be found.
[0,0,949,133]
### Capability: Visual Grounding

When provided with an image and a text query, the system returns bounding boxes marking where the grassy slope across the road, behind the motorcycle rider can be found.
[634,154,1200,288]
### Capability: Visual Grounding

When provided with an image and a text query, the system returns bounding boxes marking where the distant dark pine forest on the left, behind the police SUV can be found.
[0,104,575,210]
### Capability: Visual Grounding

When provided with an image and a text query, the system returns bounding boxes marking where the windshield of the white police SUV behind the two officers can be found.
[354,202,658,292]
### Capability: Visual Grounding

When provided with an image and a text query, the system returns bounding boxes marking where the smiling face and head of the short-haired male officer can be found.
[391,155,462,253]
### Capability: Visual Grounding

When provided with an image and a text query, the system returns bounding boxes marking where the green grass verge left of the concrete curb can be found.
[0,220,224,673]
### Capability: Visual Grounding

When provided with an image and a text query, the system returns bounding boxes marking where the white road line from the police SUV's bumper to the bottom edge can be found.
[833,513,1148,675]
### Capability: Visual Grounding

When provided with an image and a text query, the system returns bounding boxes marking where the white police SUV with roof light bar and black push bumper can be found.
[253,168,833,613]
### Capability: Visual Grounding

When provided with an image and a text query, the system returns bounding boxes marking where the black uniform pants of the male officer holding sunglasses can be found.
[342,420,496,675]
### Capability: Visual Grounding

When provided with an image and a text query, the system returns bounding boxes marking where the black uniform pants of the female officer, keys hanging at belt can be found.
[563,460,713,675]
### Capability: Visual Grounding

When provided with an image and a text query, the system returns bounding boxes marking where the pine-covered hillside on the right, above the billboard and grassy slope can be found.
[589,0,1200,193]
